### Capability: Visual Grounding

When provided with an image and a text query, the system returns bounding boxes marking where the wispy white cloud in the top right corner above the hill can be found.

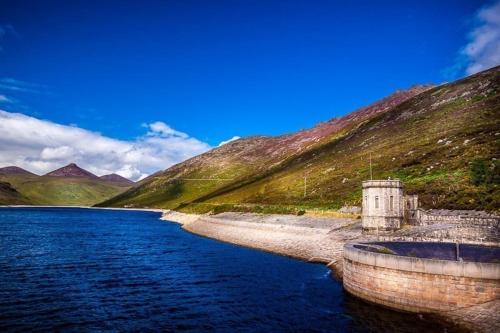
[462,1,500,75]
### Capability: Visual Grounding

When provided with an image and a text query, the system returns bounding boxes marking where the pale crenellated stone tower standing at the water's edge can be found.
[362,180,404,233]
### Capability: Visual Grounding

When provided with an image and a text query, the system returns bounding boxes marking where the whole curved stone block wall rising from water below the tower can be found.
[343,243,500,312]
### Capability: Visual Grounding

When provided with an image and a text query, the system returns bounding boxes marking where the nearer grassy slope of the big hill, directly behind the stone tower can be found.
[210,76,500,209]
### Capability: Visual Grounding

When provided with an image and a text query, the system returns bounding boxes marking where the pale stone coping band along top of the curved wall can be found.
[344,242,500,280]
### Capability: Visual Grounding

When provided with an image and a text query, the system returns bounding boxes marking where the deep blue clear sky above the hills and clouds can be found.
[0,0,496,179]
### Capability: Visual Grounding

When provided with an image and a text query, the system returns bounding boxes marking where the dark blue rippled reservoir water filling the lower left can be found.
[0,208,460,332]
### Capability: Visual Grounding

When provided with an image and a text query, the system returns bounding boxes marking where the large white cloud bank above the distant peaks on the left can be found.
[0,110,211,180]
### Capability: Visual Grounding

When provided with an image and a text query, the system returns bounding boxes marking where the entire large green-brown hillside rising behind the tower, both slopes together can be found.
[99,69,500,212]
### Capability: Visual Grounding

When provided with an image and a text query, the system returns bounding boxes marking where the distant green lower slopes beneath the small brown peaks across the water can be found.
[0,175,129,205]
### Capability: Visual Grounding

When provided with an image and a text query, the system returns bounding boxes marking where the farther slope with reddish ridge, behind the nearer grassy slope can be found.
[100,86,428,208]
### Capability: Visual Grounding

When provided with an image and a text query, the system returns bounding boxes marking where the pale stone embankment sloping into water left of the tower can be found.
[162,211,361,276]
